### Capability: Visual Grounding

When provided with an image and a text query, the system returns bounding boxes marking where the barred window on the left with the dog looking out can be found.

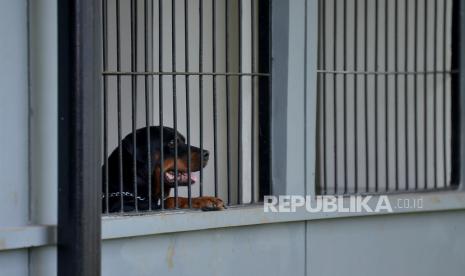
[102,0,270,213]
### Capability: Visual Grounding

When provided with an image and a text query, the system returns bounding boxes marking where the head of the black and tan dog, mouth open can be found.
[123,127,209,188]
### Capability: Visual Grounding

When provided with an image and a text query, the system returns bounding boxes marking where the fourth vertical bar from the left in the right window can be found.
[354,0,358,193]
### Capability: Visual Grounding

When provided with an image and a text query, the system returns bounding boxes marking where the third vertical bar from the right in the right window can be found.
[423,0,428,189]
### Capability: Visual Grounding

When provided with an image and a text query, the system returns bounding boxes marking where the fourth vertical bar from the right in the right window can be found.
[413,0,419,190]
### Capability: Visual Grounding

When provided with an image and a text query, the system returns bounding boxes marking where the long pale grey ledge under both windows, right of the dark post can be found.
[102,191,465,239]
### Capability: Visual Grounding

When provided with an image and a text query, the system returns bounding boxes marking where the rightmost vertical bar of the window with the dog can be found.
[250,0,255,203]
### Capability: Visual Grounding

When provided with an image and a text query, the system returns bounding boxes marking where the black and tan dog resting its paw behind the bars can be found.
[102,126,226,213]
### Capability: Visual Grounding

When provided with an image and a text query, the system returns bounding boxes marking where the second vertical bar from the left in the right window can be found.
[333,0,338,194]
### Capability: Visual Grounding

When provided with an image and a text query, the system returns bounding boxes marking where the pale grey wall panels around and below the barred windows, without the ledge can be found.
[0,0,465,276]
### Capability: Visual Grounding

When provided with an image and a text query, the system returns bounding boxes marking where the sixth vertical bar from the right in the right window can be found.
[394,0,399,191]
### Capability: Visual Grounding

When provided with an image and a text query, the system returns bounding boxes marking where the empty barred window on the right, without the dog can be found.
[317,0,458,194]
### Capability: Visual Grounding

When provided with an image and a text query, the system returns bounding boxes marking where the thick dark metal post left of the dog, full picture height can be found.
[57,0,102,276]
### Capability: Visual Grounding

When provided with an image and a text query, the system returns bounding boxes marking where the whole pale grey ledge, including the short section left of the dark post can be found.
[0,191,465,251]
